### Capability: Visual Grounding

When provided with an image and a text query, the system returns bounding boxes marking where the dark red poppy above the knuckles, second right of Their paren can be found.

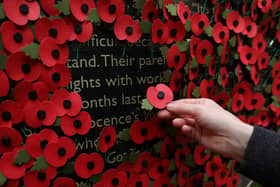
[195,40,213,64]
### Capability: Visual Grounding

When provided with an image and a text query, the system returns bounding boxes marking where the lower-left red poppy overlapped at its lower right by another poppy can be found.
[25,129,58,158]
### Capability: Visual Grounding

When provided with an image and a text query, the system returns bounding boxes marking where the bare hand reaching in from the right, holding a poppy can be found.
[158,98,253,161]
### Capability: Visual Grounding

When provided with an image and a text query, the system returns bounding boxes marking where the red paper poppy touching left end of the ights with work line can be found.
[39,64,71,91]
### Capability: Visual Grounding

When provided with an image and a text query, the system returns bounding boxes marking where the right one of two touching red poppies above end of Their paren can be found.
[166,20,186,44]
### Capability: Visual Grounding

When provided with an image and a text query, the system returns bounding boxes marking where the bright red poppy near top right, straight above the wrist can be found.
[226,11,245,34]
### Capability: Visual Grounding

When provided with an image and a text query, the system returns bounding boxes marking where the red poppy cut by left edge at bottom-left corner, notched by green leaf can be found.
[0,151,26,180]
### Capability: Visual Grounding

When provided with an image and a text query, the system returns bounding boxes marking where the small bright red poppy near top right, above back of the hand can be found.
[213,23,229,44]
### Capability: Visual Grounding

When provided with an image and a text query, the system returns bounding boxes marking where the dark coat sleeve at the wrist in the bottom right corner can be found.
[237,127,280,187]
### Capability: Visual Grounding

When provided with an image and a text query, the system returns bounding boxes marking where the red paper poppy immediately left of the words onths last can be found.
[51,88,82,117]
